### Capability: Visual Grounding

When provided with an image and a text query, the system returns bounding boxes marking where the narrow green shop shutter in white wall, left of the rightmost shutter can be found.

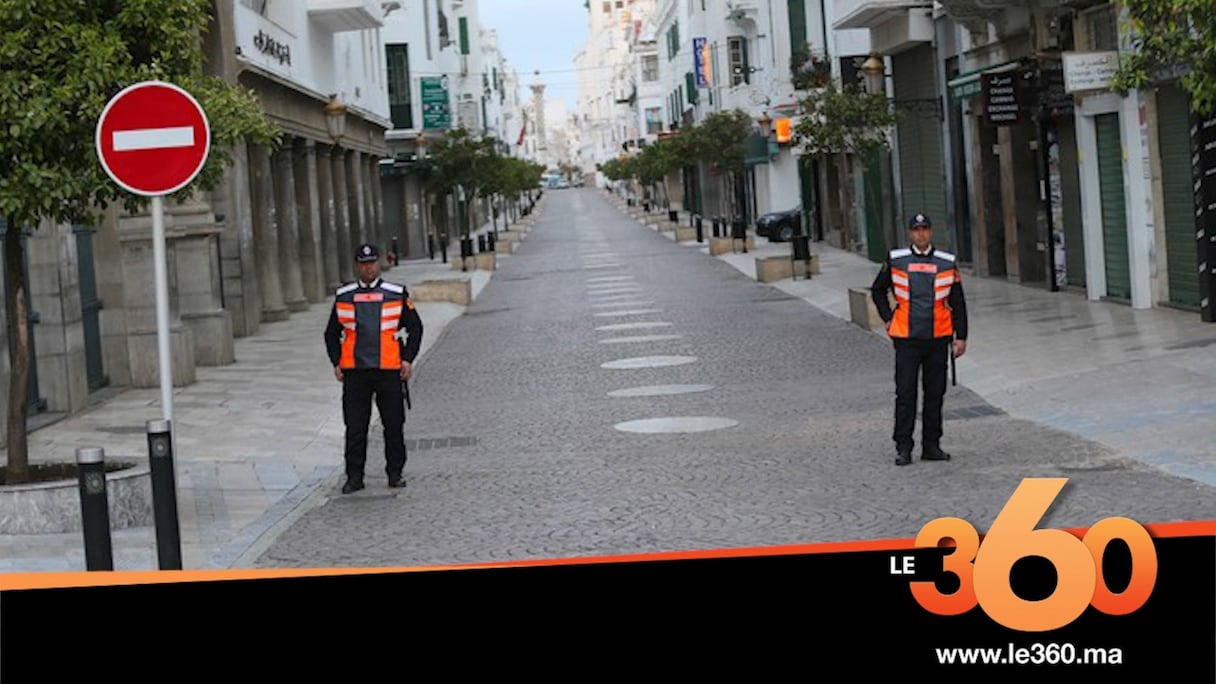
[1094,114,1132,299]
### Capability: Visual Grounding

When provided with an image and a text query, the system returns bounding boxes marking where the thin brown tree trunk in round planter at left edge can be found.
[4,220,29,484]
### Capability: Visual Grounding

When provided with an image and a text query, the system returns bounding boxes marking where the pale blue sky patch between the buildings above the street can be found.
[478,0,587,111]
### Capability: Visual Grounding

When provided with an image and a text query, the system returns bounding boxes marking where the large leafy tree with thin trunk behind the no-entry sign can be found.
[0,0,278,483]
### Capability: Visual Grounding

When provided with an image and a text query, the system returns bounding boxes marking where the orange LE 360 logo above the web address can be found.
[891,477,1158,632]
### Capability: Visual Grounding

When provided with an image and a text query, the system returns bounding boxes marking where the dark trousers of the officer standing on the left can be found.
[342,370,406,477]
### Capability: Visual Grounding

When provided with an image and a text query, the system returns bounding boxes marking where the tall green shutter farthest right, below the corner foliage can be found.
[1156,84,1199,308]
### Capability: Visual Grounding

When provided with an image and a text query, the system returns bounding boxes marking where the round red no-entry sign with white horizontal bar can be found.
[96,80,212,196]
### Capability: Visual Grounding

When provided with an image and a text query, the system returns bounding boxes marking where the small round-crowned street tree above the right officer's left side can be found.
[793,80,897,248]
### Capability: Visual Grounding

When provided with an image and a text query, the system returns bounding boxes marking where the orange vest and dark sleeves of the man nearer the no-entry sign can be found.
[325,279,422,370]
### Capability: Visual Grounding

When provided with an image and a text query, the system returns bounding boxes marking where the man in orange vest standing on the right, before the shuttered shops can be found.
[869,214,967,465]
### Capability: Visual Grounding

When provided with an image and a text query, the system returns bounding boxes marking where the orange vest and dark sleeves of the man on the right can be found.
[871,247,967,340]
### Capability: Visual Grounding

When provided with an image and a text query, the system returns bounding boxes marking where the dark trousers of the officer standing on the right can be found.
[893,337,951,450]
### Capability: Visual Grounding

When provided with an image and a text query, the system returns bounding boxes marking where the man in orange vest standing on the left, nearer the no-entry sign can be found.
[325,245,422,486]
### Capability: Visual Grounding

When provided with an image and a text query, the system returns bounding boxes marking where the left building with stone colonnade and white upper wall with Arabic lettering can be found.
[0,0,389,443]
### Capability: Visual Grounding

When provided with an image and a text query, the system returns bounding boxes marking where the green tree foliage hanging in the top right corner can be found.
[1111,0,1216,116]
